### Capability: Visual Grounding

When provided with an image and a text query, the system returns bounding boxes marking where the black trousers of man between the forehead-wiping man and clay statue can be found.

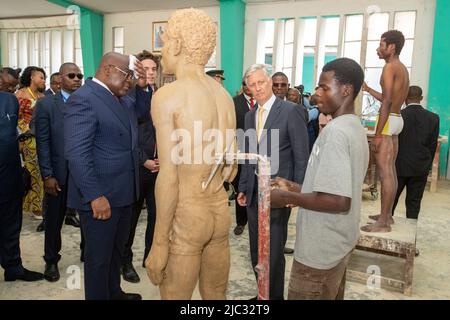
[122,169,157,264]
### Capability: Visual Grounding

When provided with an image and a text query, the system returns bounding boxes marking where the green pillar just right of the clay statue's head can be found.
[220,0,245,96]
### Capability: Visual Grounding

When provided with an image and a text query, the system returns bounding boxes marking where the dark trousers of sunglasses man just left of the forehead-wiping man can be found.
[44,185,84,264]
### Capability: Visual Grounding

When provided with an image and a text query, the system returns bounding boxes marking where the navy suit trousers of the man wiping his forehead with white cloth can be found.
[78,205,131,300]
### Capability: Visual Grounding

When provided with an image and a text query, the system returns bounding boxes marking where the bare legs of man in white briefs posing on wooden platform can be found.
[361,136,397,232]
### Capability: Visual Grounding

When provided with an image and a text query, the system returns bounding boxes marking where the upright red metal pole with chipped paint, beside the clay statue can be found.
[255,158,270,300]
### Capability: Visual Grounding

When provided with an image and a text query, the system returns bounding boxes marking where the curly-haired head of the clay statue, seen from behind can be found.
[161,8,216,74]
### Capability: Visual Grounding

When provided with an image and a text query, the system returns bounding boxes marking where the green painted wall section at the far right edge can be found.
[428,0,450,178]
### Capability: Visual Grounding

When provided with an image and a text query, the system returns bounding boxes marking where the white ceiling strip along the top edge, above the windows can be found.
[0,0,312,19]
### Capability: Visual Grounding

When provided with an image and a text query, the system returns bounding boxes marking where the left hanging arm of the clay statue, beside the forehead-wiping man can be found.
[145,89,178,285]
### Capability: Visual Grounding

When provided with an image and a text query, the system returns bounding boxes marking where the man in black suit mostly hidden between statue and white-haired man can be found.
[232,79,256,236]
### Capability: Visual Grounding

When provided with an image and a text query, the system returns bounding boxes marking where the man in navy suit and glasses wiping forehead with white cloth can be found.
[64,53,149,300]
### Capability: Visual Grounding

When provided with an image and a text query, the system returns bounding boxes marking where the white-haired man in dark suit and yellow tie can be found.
[238,64,309,300]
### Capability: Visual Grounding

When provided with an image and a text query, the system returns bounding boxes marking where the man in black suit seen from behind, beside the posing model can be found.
[392,86,439,219]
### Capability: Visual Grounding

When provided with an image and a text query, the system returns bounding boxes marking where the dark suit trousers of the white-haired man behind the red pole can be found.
[247,192,291,300]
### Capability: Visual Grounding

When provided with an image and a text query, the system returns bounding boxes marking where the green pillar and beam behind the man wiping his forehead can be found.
[47,0,103,77]
